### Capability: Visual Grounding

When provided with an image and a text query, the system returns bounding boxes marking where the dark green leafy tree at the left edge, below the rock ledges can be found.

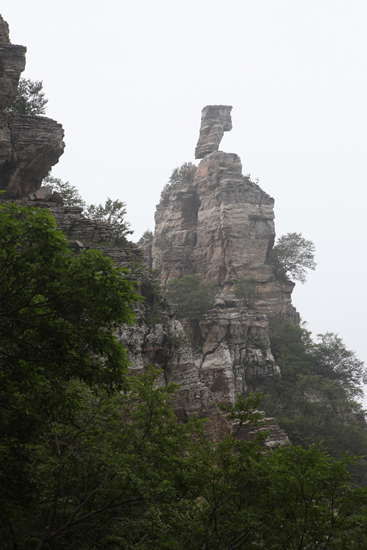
[0,203,136,544]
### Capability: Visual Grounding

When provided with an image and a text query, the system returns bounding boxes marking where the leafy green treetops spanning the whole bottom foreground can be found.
[1,364,367,550]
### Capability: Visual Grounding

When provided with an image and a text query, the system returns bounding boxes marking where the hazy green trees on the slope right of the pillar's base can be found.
[255,320,367,481]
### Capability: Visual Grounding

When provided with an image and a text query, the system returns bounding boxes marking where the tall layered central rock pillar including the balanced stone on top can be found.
[147,105,297,424]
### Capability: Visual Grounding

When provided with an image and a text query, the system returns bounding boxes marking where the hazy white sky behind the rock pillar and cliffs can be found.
[1,0,367,370]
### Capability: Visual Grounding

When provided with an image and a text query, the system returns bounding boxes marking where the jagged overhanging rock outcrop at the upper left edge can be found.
[0,12,64,198]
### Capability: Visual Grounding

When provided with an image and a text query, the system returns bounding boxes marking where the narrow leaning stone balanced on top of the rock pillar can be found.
[195,105,232,159]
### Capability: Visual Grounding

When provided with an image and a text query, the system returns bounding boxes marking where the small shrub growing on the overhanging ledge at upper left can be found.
[7,78,48,115]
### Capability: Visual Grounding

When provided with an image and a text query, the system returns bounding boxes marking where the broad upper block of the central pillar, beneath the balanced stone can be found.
[152,152,296,317]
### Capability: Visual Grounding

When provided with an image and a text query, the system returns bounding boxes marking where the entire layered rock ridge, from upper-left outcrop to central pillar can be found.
[0,16,292,446]
